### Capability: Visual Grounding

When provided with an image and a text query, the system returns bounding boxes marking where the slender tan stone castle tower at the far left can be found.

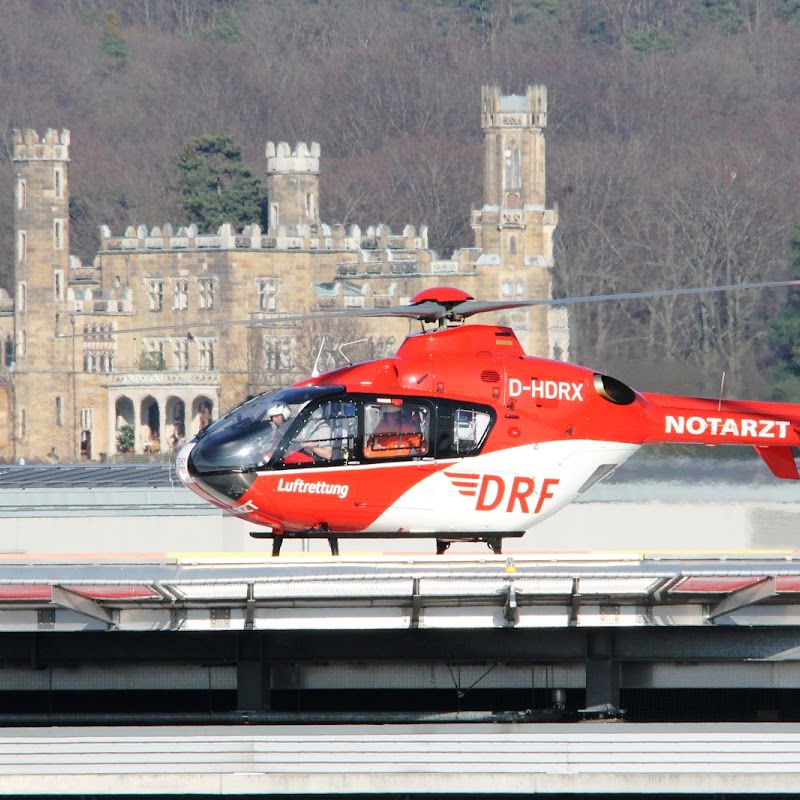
[13,129,74,458]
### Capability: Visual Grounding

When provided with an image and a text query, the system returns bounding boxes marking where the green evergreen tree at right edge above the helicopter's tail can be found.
[769,227,800,402]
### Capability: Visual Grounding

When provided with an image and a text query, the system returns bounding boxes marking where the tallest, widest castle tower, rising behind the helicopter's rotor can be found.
[472,86,566,356]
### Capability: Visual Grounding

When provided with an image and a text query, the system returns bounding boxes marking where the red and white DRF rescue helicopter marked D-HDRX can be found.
[177,281,800,555]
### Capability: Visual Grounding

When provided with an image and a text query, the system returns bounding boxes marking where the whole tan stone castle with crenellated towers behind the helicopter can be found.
[0,86,569,461]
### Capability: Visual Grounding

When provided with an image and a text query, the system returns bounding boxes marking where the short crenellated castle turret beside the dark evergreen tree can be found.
[267,142,319,231]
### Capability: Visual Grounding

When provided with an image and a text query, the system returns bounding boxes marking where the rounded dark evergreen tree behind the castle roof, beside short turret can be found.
[175,133,265,231]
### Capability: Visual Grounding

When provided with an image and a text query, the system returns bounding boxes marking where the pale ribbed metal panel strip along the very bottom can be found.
[0,723,800,796]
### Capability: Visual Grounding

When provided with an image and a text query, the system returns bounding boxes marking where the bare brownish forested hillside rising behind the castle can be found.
[0,0,800,399]
